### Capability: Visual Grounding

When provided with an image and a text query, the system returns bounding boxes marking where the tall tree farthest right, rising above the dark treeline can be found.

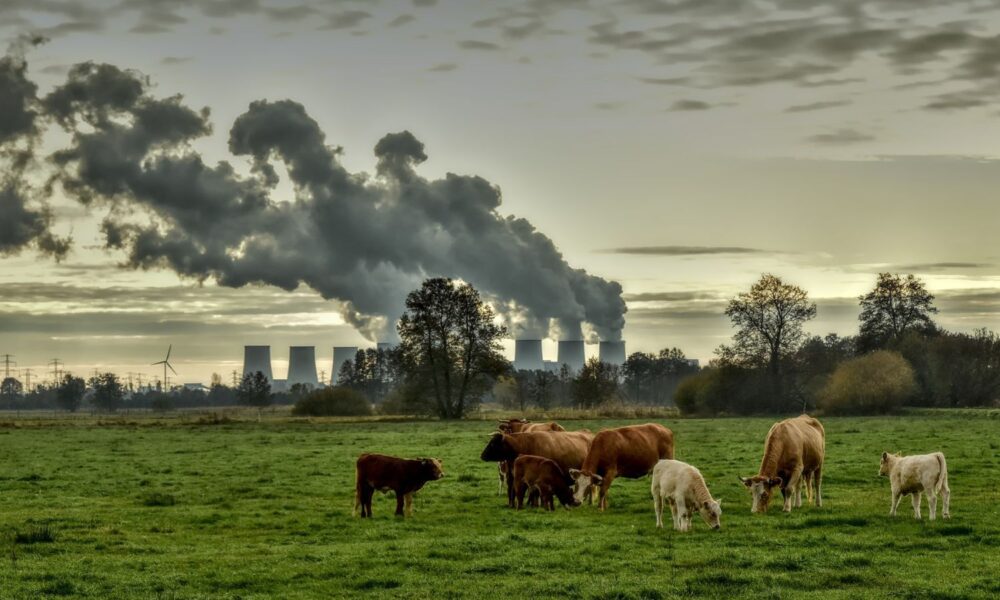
[858,273,937,351]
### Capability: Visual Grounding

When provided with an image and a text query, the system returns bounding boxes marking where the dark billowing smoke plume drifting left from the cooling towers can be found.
[1,52,625,340]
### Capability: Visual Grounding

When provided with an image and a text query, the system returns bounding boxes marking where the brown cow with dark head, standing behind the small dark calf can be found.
[479,431,594,507]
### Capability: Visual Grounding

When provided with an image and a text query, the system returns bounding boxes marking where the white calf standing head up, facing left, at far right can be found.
[878,452,951,521]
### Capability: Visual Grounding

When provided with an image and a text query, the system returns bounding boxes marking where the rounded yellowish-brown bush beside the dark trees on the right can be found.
[819,350,917,414]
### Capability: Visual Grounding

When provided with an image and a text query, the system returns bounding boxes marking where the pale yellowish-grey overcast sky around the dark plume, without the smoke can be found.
[0,0,1000,381]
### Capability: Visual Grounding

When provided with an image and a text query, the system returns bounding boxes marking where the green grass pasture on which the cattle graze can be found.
[0,413,1000,599]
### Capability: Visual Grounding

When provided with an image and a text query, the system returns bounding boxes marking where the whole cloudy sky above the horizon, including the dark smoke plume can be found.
[0,0,1000,382]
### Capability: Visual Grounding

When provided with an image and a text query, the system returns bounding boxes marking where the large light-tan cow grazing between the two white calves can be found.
[740,415,826,513]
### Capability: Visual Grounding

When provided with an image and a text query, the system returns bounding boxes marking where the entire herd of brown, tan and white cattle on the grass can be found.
[354,415,951,531]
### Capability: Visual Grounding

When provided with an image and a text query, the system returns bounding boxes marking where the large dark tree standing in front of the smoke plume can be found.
[396,278,510,419]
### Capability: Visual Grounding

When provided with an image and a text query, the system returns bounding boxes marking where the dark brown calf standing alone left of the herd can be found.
[354,454,444,518]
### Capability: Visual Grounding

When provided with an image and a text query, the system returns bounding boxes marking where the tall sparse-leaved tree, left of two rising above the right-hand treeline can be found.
[720,273,816,380]
